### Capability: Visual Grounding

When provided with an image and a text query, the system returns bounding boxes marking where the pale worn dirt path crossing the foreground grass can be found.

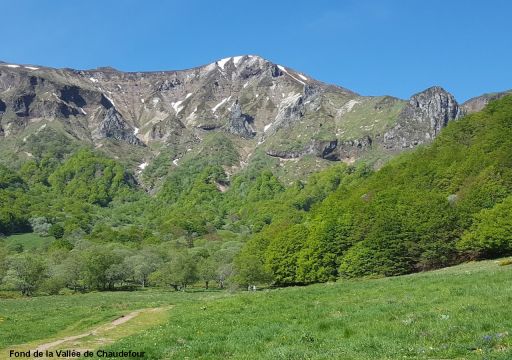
[6,306,171,358]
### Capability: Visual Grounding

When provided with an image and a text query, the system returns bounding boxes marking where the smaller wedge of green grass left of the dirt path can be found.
[0,290,228,352]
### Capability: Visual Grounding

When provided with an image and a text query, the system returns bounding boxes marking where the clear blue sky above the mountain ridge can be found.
[0,0,512,101]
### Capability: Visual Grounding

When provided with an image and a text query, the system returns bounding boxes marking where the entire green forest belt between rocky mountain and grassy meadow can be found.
[0,96,512,295]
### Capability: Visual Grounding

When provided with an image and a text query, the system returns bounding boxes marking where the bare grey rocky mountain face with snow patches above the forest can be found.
[0,55,487,186]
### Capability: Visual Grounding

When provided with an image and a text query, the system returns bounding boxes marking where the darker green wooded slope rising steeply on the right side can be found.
[239,96,512,284]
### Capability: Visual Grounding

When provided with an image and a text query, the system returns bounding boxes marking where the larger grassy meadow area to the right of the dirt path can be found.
[105,261,512,359]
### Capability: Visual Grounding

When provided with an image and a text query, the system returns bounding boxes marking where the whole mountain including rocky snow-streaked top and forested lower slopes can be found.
[0,56,512,294]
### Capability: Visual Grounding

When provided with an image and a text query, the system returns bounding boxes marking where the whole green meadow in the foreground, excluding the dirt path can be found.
[0,261,512,359]
